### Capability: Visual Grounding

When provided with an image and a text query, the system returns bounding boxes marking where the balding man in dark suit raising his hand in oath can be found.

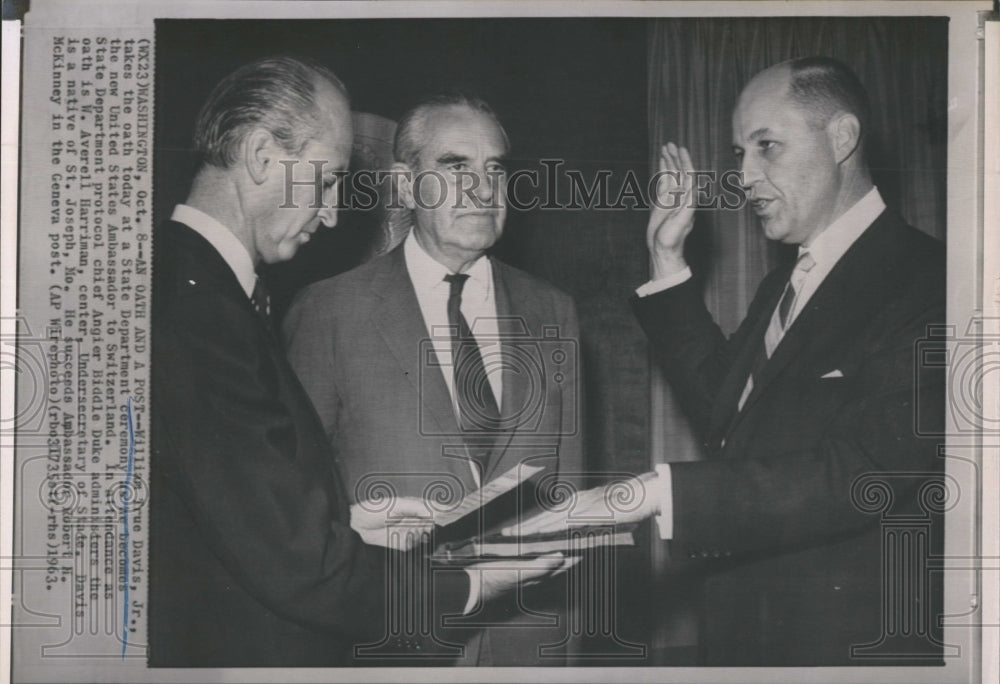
[520,58,945,665]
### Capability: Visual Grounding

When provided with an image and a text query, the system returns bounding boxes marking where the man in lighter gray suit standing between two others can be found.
[284,95,582,665]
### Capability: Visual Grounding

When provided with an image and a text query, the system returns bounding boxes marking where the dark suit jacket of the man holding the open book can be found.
[149,222,468,667]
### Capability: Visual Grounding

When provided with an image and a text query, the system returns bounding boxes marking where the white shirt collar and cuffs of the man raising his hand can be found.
[636,187,885,539]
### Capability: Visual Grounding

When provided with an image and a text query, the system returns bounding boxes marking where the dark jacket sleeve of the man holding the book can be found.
[153,293,468,638]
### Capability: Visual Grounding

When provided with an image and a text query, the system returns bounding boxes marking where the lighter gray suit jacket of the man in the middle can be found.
[284,246,582,664]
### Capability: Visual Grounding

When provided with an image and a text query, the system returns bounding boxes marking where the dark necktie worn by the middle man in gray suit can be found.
[444,273,500,475]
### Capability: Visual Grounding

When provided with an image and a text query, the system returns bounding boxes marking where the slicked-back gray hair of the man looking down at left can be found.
[194,57,347,168]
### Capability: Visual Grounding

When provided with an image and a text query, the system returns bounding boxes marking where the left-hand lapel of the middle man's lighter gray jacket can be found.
[372,247,459,434]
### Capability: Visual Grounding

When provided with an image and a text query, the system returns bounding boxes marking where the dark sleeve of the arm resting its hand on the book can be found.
[671,292,945,554]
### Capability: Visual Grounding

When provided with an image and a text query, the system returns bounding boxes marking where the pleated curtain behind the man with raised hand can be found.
[647,17,948,648]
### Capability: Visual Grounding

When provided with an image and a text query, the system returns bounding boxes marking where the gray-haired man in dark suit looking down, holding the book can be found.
[149,58,560,667]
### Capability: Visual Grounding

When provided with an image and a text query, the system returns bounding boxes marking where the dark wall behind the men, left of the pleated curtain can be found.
[154,19,649,665]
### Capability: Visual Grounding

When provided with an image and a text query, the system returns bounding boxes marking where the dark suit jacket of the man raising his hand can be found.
[633,212,945,665]
